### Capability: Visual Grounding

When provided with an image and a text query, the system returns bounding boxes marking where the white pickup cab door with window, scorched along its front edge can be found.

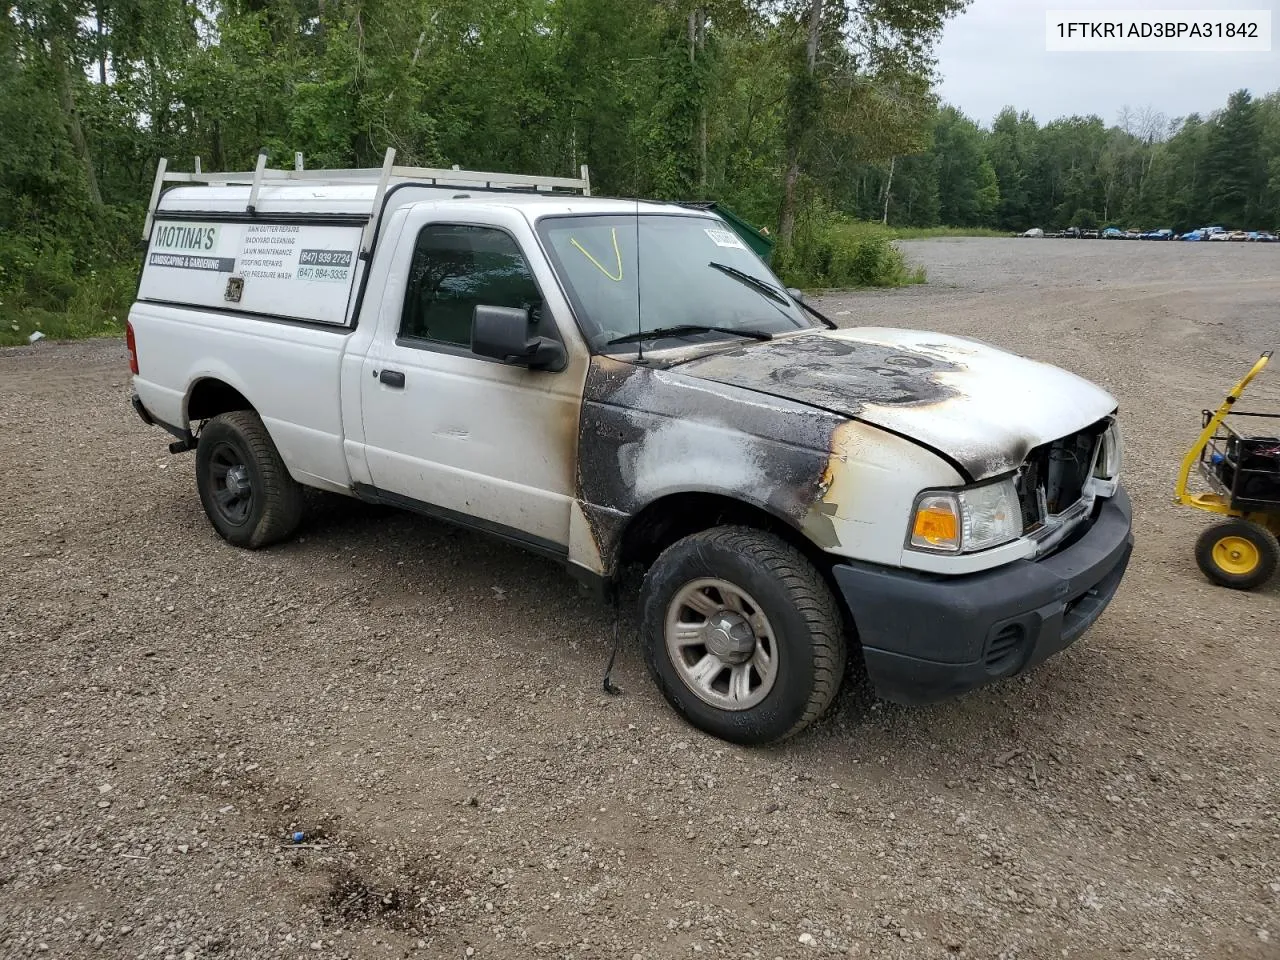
[361,204,589,554]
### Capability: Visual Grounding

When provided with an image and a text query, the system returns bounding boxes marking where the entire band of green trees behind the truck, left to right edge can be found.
[0,0,1280,343]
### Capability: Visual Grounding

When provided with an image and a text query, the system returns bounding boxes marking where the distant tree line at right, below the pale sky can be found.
[875,90,1280,233]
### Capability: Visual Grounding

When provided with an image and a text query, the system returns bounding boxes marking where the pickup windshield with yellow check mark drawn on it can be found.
[538,214,812,351]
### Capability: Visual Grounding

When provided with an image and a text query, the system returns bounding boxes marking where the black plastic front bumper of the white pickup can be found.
[833,488,1133,704]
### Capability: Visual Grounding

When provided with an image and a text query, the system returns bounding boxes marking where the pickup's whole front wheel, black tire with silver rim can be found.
[640,526,847,745]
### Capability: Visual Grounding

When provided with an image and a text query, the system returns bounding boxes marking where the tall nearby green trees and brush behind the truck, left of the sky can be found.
[0,0,964,342]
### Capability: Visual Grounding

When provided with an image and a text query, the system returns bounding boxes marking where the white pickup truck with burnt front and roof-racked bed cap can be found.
[128,155,1133,744]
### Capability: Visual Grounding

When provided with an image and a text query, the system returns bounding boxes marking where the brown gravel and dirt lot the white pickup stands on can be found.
[0,241,1280,960]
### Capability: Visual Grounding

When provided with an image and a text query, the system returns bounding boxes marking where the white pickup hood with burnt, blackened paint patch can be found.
[675,328,1116,480]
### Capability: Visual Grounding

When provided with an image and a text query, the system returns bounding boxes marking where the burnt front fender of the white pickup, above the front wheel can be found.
[570,356,963,577]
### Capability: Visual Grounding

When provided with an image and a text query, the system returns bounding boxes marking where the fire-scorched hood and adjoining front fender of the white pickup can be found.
[565,328,1115,576]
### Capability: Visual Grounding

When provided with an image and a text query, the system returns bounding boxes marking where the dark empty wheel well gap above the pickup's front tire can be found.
[617,493,835,586]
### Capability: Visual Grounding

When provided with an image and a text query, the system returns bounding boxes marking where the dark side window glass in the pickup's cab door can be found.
[399,224,541,347]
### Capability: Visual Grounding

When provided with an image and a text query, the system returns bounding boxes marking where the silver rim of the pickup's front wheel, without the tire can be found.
[666,577,778,710]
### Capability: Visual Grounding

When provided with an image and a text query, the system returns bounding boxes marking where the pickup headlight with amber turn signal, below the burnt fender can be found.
[909,479,1023,553]
